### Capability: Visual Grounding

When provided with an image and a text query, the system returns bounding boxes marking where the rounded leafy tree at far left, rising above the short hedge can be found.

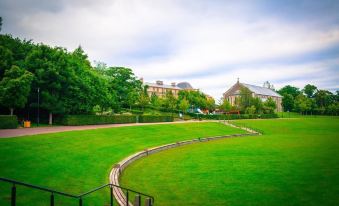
[0,66,33,115]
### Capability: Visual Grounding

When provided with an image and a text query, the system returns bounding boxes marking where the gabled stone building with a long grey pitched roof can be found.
[223,80,282,112]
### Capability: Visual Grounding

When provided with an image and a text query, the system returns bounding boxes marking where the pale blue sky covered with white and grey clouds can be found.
[0,0,339,99]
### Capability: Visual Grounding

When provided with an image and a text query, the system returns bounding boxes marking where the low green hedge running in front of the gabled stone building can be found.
[188,113,278,120]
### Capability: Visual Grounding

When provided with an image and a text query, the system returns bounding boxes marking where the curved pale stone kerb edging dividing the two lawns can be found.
[110,123,261,206]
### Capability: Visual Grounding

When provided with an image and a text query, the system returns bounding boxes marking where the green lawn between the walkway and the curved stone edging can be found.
[0,123,243,206]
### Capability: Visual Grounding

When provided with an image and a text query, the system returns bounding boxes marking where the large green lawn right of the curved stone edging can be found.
[122,118,339,206]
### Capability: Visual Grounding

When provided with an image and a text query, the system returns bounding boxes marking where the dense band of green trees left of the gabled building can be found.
[0,35,214,123]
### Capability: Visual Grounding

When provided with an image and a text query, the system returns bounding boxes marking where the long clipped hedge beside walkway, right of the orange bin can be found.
[56,115,173,126]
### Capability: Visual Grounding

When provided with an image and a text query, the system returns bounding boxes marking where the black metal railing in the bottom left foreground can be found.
[0,177,154,206]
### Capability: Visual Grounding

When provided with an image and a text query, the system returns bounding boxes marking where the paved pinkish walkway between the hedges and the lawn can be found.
[0,121,206,138]
